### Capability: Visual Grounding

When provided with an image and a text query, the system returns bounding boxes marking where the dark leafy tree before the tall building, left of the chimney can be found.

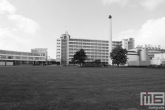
[72,49,87,65]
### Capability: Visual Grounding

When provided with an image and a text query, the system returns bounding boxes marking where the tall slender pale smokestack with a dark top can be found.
[109,15,112,64]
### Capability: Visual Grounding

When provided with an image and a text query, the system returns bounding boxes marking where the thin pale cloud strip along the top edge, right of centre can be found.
[102,0,165,10]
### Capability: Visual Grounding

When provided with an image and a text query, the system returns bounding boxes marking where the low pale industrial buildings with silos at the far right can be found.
[127,46,165,66]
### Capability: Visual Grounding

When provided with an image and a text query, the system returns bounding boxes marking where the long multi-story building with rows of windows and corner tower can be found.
[56,32,134,64]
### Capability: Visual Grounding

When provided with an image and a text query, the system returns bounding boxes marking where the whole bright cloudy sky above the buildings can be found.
[0,0,165,58]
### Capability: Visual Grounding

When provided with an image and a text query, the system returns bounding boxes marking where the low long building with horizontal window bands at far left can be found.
[0,50,46,65]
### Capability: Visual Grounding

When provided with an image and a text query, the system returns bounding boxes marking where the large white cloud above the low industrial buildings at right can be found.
[113,17,165,48]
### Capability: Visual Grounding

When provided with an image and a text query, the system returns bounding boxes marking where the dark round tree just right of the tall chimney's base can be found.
[110,46,127,66]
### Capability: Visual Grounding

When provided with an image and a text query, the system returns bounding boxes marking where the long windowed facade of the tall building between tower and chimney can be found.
[69,39,110,63]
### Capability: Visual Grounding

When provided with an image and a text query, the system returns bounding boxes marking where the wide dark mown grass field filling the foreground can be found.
[0,66,165,110]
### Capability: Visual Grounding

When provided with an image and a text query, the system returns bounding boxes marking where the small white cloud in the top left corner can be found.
[0,0,16,14]
